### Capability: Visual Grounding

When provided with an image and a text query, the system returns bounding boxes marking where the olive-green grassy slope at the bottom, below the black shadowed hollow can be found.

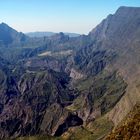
[62,116,113,140]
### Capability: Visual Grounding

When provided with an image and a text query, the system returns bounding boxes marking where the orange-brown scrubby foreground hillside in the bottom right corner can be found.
[105,104,140,140]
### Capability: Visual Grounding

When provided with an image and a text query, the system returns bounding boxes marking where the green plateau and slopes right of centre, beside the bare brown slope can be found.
[67,71,127,113]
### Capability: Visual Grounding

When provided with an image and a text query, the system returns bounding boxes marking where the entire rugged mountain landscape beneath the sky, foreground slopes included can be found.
[0,7,140,140]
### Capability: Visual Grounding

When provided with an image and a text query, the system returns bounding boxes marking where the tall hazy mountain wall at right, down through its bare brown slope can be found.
[76,7,140,125]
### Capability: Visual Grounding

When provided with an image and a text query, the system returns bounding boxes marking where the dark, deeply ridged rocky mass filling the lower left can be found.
[0,68,79,139]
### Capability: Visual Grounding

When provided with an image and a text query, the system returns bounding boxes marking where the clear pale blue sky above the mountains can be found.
[0,0,140,34]
